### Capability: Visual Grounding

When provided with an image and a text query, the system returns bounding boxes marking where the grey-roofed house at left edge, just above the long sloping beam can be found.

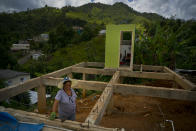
[0,69,30,87]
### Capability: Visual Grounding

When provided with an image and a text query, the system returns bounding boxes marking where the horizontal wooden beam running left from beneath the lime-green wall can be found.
[72,67,115,75]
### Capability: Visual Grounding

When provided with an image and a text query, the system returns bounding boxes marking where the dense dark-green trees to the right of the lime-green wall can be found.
[135,19,196,69]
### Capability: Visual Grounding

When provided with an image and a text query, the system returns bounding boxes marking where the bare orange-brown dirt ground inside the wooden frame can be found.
[76,94,196,131]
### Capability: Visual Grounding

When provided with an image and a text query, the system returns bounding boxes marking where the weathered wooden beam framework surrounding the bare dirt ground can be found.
[0,62,196,130]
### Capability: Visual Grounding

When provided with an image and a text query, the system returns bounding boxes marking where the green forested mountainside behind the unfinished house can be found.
[0,3,196,109]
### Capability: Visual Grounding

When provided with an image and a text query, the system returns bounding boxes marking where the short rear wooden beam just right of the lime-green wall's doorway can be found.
[133,64,163,72]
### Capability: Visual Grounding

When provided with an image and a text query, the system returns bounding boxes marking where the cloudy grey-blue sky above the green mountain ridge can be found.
[0,0,196,20]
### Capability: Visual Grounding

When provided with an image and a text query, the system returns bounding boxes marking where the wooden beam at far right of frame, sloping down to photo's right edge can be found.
[163,67,196,90]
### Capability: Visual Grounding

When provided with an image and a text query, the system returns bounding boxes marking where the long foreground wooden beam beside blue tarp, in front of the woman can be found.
[0,106,120,131]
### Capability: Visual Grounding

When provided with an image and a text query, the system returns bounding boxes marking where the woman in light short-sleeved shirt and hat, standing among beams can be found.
[50,77,77,121]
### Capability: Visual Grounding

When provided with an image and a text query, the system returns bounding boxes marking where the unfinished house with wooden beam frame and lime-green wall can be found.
[0,25,196,131]
